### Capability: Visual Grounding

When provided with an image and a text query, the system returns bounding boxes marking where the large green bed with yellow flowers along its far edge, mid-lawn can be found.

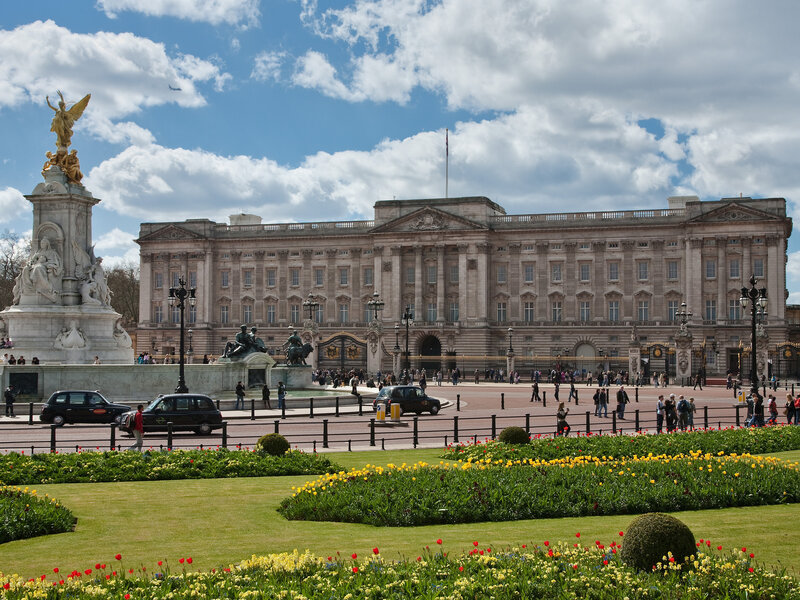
[279,453,800,526]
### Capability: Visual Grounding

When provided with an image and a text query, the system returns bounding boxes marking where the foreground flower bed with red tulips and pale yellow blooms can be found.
[0,534,800,600]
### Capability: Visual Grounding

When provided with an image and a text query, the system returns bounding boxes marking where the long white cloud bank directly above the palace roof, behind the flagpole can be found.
[84,104,675,221]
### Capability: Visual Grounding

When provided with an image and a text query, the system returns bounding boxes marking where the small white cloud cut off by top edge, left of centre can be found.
[97,0,260,27]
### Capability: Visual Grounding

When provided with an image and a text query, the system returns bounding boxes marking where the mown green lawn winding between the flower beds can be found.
[0,450,800,577]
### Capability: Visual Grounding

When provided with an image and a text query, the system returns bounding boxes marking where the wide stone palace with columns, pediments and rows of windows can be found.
[136,196,800,377]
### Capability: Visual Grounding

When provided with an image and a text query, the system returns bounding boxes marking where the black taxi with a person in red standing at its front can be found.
[119,394,222,435]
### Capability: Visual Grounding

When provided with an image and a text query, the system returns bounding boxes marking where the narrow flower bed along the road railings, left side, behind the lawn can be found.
[0,449,339,485]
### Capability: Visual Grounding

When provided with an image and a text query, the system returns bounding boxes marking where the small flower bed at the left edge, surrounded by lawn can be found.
[0,486,75,543]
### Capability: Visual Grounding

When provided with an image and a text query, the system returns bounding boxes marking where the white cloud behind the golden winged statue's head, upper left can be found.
[0,21,230,143]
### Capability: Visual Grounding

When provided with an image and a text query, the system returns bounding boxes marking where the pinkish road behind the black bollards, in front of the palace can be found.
[0,383,780,453]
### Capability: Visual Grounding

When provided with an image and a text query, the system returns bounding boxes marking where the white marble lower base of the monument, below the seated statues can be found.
[0,304,133,365]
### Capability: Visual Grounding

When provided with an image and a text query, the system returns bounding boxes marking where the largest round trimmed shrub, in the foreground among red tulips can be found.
[620,513,697,571]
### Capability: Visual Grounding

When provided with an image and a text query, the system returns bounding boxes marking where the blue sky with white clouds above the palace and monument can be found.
[0,0,800,302]
